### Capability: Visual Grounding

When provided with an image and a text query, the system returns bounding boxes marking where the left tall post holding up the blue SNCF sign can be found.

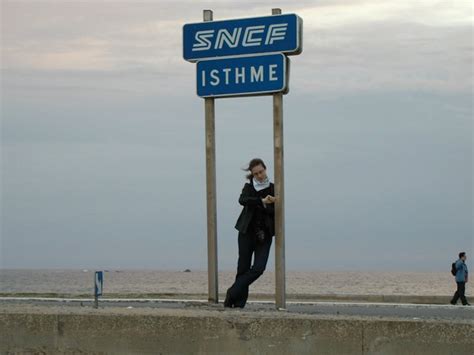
[203,10,219,303]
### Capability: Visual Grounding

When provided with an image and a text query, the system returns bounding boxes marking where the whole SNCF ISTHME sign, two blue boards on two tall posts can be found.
[183,9,303,309]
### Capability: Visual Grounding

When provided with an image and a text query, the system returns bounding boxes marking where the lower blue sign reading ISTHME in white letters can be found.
[196,54,288,97]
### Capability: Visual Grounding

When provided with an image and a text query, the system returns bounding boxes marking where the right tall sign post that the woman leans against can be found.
[272,5,286,309]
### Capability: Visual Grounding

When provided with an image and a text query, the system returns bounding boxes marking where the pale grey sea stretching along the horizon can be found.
[0,269,474,297]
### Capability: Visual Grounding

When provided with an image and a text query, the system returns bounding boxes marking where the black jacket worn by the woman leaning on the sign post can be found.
[235,183,275,236]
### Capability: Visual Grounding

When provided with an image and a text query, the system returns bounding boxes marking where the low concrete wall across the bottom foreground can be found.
[0,305,474,354]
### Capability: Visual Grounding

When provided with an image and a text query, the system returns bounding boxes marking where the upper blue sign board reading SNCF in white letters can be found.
[183,14,302,62]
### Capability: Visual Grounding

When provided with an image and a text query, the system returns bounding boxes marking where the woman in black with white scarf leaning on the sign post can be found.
[224,158,275,308]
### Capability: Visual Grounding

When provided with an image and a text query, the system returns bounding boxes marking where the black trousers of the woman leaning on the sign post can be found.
[227,232,273,308]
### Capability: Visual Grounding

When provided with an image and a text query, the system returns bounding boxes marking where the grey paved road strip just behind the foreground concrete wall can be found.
[0,297,474,324]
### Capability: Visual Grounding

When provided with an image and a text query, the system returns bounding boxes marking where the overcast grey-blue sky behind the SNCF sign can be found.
[0,0,474,272]
